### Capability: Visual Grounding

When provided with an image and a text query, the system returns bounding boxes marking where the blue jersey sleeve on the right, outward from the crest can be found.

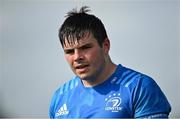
[133,75,171,118]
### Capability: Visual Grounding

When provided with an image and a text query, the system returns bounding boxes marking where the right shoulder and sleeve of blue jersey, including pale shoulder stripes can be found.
[116,64,171,117]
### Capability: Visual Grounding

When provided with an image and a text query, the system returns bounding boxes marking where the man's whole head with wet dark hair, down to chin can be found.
[59,7,110,80]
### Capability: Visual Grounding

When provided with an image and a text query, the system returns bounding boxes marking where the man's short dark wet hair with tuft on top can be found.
[58,6,107,47]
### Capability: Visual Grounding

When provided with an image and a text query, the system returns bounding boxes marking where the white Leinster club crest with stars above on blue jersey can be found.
[105,93,122,112]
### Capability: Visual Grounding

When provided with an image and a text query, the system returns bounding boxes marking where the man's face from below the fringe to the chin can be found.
[63,33,109,80]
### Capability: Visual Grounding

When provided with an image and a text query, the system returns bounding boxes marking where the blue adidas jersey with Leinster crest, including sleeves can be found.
[50,65,171,118]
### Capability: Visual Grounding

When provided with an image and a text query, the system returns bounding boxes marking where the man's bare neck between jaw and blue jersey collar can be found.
[82,61,117,87]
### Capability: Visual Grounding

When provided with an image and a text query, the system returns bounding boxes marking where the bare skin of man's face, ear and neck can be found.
[63,32,116,87]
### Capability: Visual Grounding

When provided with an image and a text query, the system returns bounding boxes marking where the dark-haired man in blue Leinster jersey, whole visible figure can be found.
[50,7,171,118]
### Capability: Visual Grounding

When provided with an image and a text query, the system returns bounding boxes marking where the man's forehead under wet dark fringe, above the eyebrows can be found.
[63,32,97,49]
